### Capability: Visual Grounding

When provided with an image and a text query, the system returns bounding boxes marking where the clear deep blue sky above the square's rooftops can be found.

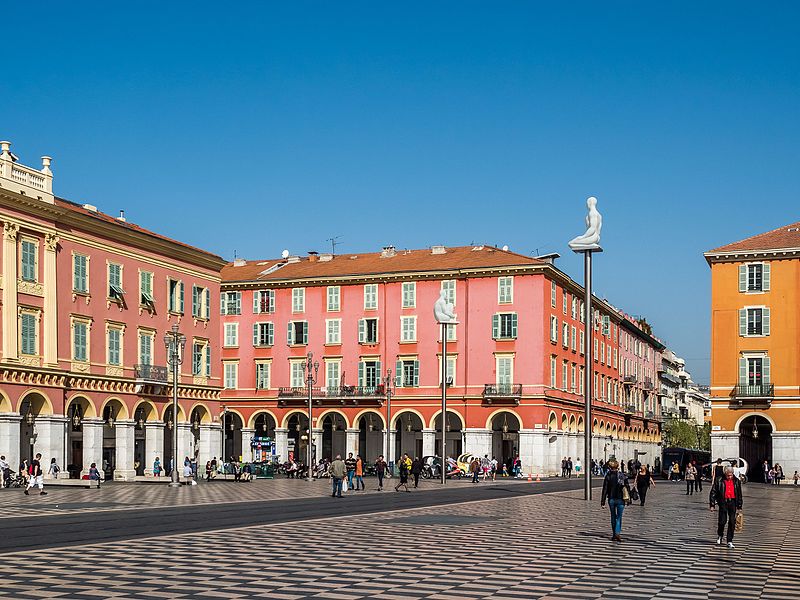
[0,2,800,383]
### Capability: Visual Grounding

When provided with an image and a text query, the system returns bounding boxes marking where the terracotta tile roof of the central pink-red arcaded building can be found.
[222,246,546,283]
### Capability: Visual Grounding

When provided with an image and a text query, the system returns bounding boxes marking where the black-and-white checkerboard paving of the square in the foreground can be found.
[0,482,800,600]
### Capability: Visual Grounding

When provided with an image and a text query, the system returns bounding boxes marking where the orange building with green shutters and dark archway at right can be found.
[705,223,800,481]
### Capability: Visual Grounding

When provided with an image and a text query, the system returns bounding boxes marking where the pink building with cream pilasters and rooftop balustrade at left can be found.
[0,142,224,480]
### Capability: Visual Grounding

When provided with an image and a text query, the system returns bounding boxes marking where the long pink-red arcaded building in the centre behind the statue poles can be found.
[221,246,660,474]
